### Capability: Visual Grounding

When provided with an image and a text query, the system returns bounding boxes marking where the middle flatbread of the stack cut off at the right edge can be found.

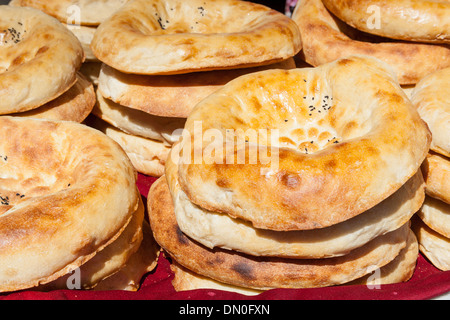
[422,152,450,204]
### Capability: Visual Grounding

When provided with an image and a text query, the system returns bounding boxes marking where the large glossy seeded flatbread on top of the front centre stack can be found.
[178,57,431,231]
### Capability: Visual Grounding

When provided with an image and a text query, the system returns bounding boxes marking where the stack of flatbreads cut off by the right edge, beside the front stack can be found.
[411,68,450,270]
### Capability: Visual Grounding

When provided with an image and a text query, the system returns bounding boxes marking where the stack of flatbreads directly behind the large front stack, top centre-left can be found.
[86,0,301,176]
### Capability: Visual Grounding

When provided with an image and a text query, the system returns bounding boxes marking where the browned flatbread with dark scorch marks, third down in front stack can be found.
[147,176,409,290]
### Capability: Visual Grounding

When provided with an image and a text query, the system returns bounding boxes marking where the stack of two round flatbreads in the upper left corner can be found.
[0,6,95,122]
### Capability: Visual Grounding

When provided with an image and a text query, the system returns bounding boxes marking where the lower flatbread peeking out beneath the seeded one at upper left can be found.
[10,73,96,123]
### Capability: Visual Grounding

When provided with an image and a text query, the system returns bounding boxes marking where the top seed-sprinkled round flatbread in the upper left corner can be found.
[0,6,84,114]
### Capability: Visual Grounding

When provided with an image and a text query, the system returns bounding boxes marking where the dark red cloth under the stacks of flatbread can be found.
[0,175,450,300]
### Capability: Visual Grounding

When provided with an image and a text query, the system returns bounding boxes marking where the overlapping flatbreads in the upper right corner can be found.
[292,0,450,87]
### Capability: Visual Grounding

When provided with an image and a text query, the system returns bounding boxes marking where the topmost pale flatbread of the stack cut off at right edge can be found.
[411,68,450,157]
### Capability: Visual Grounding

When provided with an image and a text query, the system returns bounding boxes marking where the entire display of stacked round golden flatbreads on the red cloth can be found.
[0,0,450,294]
